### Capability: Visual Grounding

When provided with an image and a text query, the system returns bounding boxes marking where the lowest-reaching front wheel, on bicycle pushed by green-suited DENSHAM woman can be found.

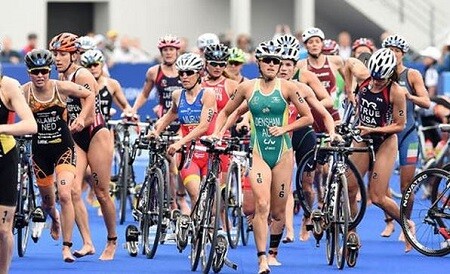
[202,178,221,273]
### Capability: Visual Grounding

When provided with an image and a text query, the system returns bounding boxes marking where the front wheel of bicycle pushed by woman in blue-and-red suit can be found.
[142,168,164,259]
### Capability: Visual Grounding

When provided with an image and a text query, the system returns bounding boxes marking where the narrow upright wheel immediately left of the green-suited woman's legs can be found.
[224,163,243,248]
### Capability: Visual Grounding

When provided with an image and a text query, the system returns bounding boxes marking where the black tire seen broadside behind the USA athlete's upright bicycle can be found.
[295,150,367,230]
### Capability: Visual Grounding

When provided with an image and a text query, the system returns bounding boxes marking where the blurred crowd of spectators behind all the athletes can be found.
[0,25,450,96]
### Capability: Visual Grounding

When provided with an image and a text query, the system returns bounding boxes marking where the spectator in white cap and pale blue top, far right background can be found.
[420,47,441,97]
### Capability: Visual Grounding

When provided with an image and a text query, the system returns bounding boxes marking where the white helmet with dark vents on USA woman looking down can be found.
[367,48,397,79]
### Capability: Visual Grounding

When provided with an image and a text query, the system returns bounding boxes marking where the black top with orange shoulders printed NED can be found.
[28,82,73,146]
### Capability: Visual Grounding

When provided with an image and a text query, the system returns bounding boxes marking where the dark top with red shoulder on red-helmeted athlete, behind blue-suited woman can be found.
[155,65,183,116]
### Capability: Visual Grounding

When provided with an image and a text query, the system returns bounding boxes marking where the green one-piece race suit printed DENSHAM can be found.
[248,79,292,168]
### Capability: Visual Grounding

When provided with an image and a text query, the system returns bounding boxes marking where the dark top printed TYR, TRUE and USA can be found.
[357,78,392,127]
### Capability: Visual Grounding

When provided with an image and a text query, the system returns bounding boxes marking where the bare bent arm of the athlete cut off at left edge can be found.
[0,76,37,136]
